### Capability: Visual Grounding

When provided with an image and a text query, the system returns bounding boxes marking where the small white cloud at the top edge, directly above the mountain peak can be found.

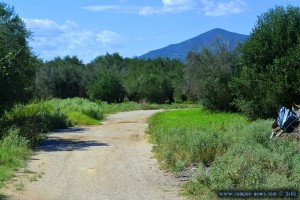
[201,0,249,17]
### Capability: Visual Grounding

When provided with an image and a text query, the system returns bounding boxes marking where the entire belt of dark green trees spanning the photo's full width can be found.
[0,3,300,118]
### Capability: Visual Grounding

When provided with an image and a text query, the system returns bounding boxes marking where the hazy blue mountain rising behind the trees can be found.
[139,28,249,62]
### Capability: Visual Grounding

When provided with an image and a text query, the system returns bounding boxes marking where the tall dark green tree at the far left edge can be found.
[0,3,39,112]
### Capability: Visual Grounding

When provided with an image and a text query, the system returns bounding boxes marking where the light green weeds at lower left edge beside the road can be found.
[0,129,31,188]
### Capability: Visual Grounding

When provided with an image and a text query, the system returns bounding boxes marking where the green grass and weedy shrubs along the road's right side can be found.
[148,109,300,199]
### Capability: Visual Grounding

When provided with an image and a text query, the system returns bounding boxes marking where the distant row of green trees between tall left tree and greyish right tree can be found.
[35,53,184,103]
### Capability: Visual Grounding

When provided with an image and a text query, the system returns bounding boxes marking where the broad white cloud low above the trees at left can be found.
[24,19,125,62]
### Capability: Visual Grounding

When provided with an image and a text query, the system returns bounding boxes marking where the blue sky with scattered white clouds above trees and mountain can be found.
[4,0,300,63]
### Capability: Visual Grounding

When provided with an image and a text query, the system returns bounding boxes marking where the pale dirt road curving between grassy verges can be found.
[4,111,183,200]
